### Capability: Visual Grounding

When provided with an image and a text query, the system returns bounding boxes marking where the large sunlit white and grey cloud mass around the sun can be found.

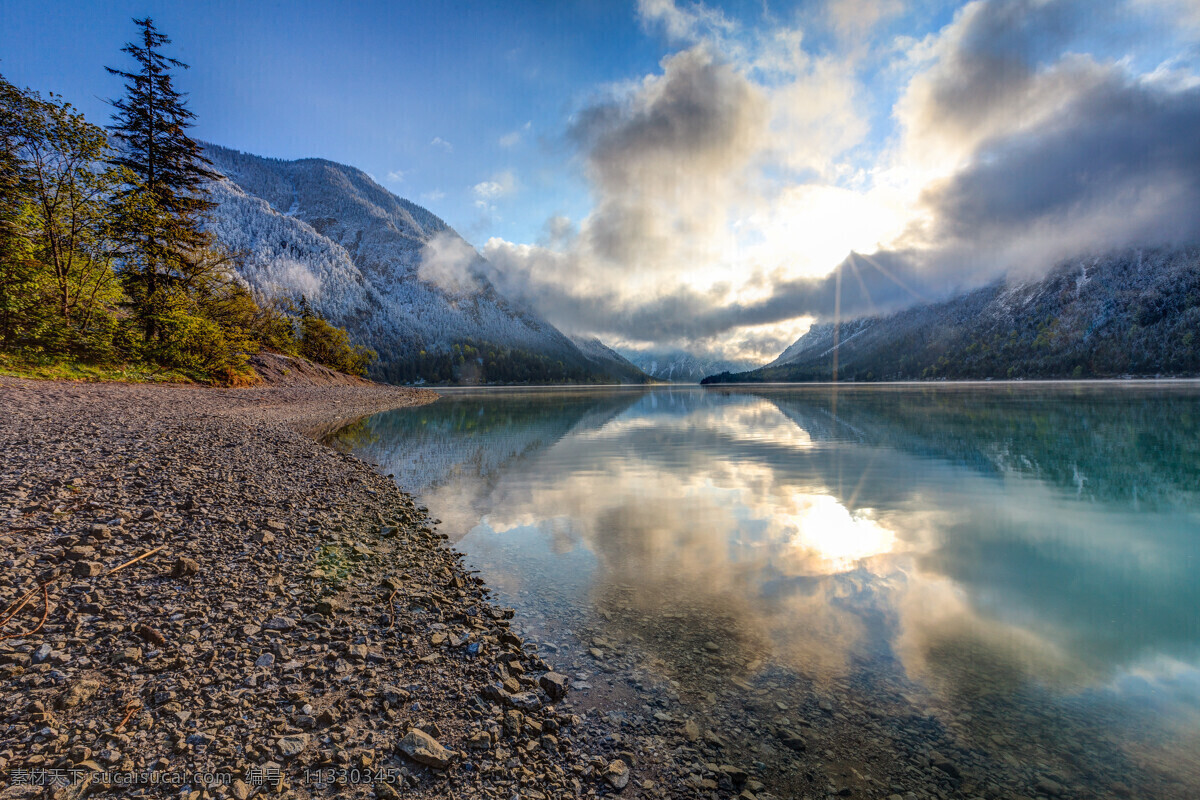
[476,0,1200,360]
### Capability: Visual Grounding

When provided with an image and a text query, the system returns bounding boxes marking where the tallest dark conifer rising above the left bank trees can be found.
[106,17,220,343]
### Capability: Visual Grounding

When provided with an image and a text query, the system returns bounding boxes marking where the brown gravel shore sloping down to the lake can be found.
[0,379,632,800]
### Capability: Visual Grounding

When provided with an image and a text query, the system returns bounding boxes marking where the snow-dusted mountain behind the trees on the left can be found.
[204,144,625,383]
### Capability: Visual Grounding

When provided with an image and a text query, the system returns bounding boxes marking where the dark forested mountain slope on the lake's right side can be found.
[704,246,1200,383]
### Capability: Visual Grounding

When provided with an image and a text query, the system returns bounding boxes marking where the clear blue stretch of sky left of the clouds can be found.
[0,0,666,241]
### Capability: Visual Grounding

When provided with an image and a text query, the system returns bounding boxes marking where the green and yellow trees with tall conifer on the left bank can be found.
[0,18,374,383]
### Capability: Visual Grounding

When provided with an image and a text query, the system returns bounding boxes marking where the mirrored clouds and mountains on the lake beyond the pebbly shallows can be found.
[336,384,1200,788]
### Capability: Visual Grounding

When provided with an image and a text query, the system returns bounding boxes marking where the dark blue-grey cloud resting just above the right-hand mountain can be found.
[923,80,1200,246]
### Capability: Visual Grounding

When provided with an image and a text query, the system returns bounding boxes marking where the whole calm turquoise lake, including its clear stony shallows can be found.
[332,383,1200,798]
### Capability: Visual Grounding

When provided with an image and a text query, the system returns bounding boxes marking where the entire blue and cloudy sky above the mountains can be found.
[0,0,1200,361]
